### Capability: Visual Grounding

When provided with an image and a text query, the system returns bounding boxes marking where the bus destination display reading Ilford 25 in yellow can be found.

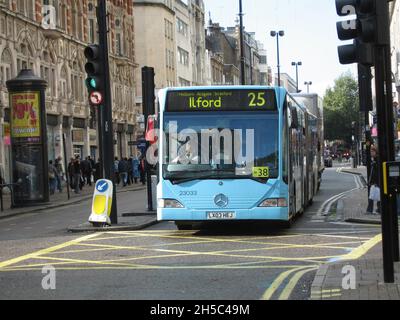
[165,89,278,112]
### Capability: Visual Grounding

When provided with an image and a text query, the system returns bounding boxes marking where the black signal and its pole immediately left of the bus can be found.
[142,67,156,211]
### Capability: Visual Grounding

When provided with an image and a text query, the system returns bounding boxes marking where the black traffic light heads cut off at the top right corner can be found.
[336,0,390,66]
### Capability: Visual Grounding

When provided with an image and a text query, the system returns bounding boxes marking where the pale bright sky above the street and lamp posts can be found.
[204,0,357,96]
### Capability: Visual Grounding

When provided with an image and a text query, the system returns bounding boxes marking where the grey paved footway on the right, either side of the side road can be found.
[311,167,400,300]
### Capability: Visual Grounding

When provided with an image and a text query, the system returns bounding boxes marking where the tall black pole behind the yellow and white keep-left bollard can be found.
[97,0,118,224]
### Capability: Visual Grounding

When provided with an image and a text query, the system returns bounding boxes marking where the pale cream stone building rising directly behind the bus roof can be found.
[133,0,206,106]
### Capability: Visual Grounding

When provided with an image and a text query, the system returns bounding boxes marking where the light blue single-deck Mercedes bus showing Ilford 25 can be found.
[157,86,319,230]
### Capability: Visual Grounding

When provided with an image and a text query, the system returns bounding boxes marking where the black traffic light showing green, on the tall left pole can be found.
[84,45,105,102]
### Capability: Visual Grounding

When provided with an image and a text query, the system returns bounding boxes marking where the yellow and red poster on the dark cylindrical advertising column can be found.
[10,92,41,144]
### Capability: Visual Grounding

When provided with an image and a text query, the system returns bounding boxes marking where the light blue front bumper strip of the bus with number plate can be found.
[157,207,289,222]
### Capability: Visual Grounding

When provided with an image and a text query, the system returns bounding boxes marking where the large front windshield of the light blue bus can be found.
[163,112,279,182]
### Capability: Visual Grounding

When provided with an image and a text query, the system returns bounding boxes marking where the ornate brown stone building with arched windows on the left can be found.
[0,0,140,182]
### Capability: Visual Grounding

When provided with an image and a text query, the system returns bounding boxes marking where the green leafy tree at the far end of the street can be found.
[324,72,359,145]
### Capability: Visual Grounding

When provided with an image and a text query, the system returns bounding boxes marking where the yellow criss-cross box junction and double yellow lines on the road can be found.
[0,231,382,300]
